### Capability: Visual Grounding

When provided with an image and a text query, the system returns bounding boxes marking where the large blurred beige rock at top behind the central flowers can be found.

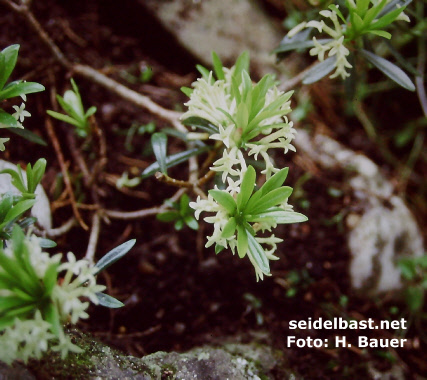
[139,0,283,74]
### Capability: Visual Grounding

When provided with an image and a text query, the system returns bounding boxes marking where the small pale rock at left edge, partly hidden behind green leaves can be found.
[0,160,52,230]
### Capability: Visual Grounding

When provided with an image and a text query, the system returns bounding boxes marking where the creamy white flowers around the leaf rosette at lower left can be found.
[0,236,105,364]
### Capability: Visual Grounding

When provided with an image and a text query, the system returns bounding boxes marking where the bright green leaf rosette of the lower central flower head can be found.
[209,166,307,274]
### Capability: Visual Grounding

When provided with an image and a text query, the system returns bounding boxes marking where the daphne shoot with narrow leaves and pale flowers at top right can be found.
[275,0,415,91]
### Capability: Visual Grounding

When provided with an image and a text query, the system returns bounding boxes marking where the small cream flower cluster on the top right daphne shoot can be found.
[288,5,353,79]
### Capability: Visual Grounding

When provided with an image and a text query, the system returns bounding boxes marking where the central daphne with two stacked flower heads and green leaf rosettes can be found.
[143,52,307,279]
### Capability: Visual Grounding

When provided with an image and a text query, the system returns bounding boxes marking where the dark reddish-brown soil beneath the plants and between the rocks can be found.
[0,0,427,379]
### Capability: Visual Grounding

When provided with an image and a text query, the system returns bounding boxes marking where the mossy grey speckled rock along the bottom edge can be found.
[25,330,299,380]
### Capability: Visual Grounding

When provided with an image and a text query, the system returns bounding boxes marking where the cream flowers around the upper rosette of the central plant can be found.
[181,67,296,182]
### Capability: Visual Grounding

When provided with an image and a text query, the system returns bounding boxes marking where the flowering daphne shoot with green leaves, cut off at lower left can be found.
[0,226,135,364]
